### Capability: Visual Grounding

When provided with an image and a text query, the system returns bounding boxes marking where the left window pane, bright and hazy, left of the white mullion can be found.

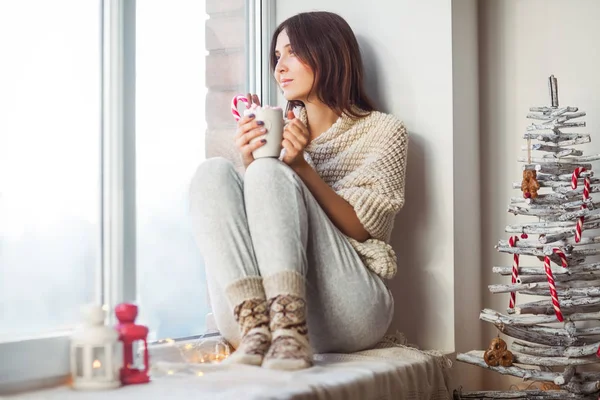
[0,0,101,340]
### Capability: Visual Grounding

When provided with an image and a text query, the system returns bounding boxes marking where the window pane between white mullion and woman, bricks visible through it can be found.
[136,0,246,340]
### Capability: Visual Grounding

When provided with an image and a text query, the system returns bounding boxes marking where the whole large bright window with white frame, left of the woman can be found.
[0,0,274,392]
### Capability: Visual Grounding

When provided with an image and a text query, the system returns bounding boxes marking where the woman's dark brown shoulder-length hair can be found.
[270,11,375,118]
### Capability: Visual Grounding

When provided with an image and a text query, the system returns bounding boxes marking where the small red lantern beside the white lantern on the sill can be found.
[115,303,150,385]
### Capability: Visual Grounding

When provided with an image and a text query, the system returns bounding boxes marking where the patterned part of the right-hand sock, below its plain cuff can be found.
[262,294,313,370]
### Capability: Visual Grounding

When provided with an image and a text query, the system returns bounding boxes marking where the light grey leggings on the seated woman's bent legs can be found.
[190,158,394,353]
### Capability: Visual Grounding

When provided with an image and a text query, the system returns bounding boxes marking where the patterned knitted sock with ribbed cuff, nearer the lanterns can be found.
[224,277,271,365]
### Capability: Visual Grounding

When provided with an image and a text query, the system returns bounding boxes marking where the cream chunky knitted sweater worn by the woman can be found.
[295,107,408,279]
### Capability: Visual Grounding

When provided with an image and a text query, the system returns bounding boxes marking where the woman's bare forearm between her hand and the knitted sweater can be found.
[291,160,371,242]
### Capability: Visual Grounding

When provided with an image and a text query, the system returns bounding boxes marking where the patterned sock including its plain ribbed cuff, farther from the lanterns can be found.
[262,271,313,370]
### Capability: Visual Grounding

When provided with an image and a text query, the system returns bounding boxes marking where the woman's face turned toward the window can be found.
[274,30,315,102]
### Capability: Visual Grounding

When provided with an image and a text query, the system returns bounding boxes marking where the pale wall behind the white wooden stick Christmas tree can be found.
[480,0,600,390]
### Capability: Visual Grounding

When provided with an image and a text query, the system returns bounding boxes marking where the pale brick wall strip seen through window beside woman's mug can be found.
[206,0,246,168]
